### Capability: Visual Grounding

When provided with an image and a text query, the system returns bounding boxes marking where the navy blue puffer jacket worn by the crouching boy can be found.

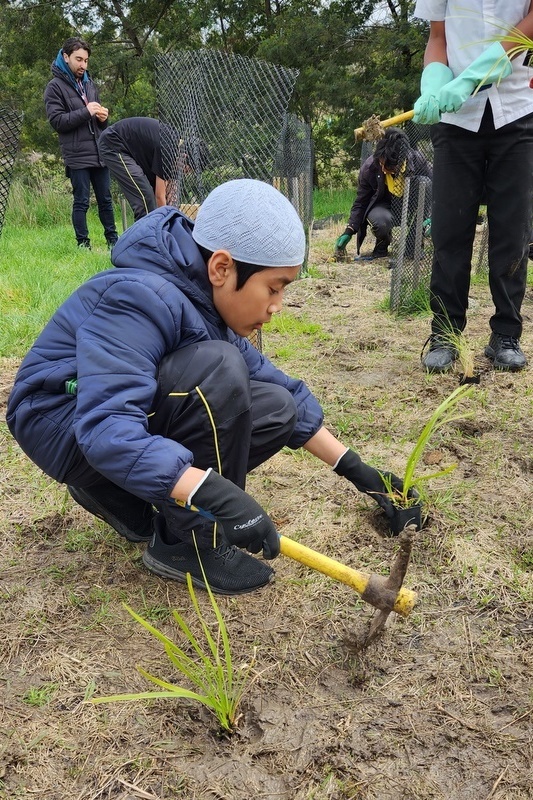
[7,206,323,502]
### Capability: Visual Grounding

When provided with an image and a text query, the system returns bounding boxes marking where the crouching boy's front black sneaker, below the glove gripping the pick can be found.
[143,524,275,594]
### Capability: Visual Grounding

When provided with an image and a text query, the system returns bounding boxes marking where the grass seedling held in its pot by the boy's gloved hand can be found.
[382,385,474,508]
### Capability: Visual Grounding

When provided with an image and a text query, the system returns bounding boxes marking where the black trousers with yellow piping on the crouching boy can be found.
[65,341,297,547]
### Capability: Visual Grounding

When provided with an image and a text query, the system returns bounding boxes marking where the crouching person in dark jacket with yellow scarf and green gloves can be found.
[335,128,432,261]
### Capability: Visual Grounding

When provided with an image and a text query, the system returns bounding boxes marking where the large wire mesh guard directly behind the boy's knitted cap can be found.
[155,50,313,348]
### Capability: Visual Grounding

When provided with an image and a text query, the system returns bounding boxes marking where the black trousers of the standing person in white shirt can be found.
[430,103,533,338]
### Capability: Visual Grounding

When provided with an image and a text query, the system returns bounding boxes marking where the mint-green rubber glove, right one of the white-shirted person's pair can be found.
[439,42,513,113]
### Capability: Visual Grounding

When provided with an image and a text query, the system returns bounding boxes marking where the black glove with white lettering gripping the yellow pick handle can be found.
[190,470,279,558]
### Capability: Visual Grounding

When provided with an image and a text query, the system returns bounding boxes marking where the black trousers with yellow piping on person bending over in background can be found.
[98,131,156,221]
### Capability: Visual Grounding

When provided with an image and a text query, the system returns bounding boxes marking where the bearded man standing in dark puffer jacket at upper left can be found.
[44,37,118,249]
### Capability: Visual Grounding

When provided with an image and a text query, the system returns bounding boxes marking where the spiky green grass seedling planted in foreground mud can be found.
[87,562,257,734]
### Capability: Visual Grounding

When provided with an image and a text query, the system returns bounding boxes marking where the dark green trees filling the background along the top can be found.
[0,0,426,186]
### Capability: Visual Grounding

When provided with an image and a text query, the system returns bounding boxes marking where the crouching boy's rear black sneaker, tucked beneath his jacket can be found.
[67,485,155,542]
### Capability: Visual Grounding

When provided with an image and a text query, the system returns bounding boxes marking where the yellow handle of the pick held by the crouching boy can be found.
[279,536,417,617]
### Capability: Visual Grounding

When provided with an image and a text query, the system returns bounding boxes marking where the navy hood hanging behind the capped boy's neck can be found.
[111,206,221,326]
